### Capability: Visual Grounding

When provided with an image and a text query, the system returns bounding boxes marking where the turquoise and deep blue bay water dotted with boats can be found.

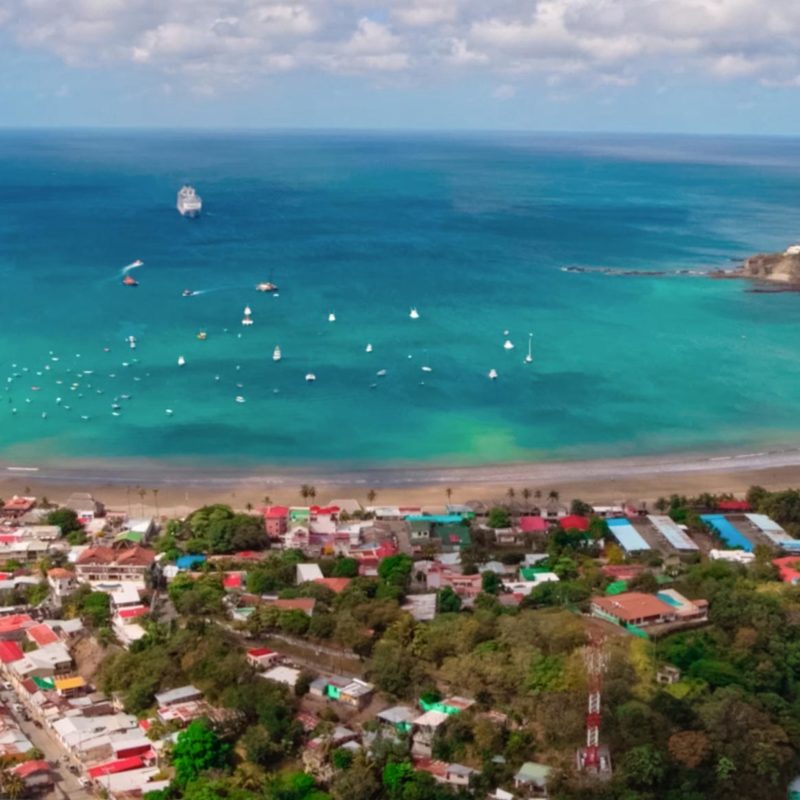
[0,132,800,467]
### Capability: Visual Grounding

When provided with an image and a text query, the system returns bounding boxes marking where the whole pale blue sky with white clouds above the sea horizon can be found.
[0,0,800,135]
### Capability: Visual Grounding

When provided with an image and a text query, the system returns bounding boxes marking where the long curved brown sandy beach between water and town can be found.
[0,449,800,515]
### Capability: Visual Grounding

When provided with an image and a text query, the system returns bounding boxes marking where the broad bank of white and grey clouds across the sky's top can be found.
[0,0,800,86]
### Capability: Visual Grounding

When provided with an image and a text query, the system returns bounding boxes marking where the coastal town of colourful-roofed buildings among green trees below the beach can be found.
[0,486,800,800]
